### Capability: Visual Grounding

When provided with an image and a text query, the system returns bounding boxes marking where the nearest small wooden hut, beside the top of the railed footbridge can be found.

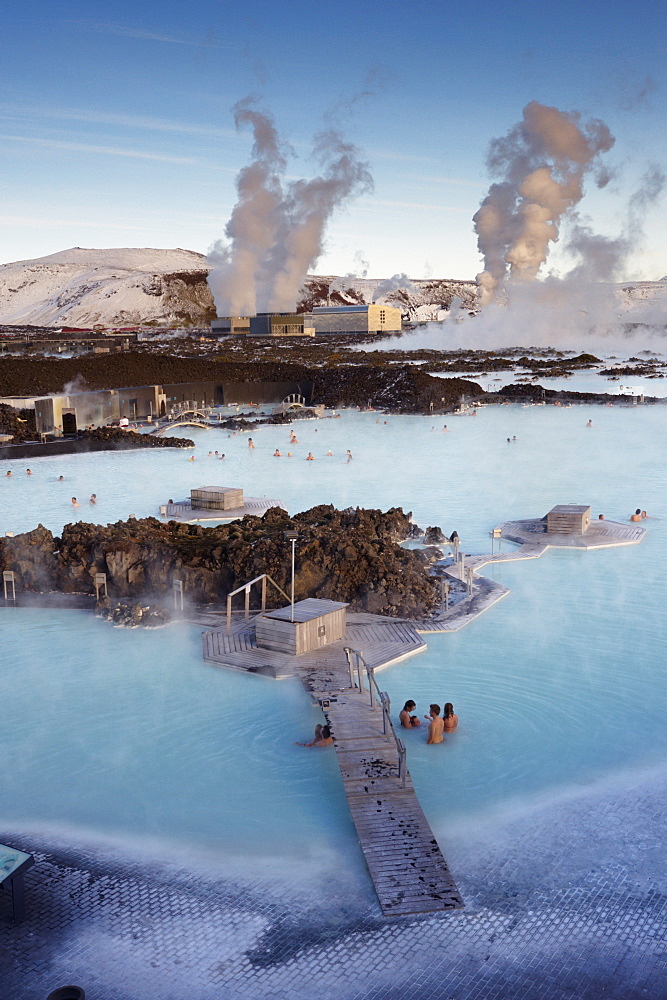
[255,597,347,656]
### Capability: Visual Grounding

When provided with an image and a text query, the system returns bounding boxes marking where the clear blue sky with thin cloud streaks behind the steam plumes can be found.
[0,0,667,279]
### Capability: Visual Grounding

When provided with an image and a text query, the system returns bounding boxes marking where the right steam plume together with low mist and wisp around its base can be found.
[460,101,667,351]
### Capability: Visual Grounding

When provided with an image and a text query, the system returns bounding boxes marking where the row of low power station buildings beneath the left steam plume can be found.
[211,303,402,337]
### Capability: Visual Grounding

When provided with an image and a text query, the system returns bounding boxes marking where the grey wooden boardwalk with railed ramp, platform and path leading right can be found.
[194,520,645,917]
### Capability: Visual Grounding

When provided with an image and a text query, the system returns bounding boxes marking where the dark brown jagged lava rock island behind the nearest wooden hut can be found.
[0,504,437,618]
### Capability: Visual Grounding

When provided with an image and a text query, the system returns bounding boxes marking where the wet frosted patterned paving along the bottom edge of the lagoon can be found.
[0,776,667,1000]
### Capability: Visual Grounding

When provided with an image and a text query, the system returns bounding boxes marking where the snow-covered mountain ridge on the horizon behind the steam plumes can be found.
[0,247,667,327]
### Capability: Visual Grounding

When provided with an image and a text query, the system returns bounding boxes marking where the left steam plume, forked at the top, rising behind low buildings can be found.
[208,98,373,316]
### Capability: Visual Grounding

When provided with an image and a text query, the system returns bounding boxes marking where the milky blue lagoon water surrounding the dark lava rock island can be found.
[0,406,667,858]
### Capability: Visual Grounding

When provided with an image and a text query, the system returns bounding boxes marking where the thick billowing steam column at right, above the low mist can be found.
[473,101,614,305]
